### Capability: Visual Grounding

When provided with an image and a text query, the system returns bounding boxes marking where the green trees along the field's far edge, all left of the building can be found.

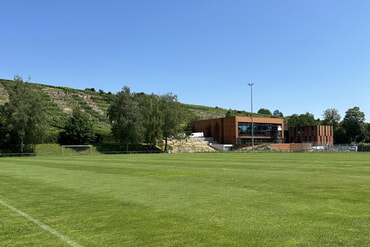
[0,76,190,153]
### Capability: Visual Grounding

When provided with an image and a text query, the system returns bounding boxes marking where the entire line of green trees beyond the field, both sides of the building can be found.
[0,76,370,152]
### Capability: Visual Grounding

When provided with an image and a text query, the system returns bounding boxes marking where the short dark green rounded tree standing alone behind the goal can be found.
[60,108,95,144]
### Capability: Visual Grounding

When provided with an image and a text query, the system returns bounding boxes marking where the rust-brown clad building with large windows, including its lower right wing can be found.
[192,116,334,145]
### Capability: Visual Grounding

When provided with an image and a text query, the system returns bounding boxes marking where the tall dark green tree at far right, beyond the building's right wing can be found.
[342,106,367,142]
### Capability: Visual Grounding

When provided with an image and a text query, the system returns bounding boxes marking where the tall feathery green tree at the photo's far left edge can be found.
[2,76,47,153]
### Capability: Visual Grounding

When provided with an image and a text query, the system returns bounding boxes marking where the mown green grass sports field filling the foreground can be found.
[0,153,370,247]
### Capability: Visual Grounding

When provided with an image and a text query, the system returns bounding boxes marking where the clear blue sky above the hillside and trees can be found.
[0,0,370,120]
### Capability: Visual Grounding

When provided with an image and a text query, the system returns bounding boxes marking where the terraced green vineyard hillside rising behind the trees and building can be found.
[0,79,276,131]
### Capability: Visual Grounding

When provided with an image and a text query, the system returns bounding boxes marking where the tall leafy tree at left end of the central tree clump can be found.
[108,86,144,151]
